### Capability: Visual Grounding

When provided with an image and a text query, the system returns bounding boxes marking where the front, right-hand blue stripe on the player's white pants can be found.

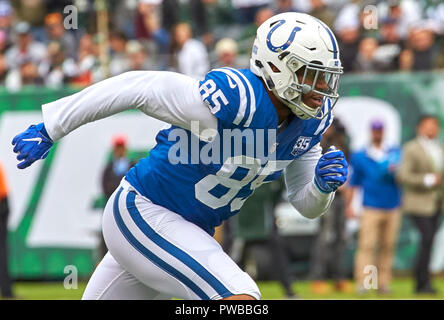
[126,192,233,298]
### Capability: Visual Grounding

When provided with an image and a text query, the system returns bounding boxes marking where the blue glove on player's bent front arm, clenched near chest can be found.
[314,146,348,193]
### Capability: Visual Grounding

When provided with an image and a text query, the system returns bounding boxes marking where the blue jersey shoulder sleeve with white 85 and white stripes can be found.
[199,68,254,126]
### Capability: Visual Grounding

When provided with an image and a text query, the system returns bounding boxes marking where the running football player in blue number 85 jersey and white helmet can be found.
[12,12,348,299]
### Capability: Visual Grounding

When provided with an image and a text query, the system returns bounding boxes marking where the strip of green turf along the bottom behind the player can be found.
[3,278,444,300]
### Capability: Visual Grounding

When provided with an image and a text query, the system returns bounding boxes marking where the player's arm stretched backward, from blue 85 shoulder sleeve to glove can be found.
[12,68,255,169]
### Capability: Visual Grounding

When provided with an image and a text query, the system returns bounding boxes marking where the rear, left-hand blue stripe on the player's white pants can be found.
[113,188,210,300]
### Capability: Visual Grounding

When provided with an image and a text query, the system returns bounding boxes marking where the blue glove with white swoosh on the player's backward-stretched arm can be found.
[12,123,53,169]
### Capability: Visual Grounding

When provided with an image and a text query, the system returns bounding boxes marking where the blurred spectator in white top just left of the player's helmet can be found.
[172,23,210,79]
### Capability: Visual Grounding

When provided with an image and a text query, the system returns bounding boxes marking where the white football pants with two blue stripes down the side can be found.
[83,180,260,300]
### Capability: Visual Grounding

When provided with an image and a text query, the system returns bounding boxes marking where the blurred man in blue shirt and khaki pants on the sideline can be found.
[346,120,401,294]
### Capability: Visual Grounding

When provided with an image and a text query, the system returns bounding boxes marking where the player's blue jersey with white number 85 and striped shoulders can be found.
[126,68,333,235]
